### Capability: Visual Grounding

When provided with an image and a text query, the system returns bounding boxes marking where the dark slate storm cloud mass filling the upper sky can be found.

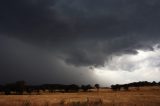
[0,0,160,66]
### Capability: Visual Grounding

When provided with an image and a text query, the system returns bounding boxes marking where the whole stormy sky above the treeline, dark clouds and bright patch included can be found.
[0,0,160,86]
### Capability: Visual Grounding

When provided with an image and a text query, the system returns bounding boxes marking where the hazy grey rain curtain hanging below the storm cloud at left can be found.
[0,36,95,84]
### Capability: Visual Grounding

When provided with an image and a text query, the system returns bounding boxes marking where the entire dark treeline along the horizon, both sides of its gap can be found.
[0,81,160,95]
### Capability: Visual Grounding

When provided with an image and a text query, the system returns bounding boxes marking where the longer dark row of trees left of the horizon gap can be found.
[0,81,99,95]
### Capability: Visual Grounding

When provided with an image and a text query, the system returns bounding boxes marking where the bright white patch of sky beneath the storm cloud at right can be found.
[94,45,160,85]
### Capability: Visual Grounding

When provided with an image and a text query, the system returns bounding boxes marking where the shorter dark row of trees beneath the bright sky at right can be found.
[111,81,160,91]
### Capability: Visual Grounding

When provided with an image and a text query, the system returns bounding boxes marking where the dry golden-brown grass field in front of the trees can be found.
[0,87,160,106]
